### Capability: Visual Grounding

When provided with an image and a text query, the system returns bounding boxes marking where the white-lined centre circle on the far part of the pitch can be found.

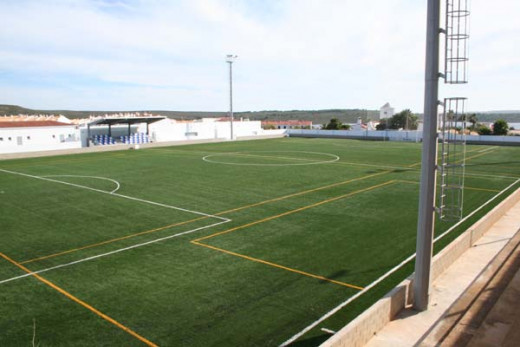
[202,151,339,166]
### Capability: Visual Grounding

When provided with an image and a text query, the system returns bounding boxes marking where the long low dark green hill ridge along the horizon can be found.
[0,105,520,124]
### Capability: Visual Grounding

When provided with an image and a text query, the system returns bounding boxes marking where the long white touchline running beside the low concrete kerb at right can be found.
[280,179,520,346]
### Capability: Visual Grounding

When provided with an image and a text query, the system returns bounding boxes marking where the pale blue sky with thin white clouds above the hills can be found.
[0,0,520,112]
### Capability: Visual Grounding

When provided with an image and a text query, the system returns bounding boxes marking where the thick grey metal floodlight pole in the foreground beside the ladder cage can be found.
[413,0,440,311]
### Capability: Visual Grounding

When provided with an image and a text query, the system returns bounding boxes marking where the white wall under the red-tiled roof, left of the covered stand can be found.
[0,125,81,153]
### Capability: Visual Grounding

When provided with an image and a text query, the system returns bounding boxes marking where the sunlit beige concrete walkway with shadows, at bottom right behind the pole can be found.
[367,197,520,347]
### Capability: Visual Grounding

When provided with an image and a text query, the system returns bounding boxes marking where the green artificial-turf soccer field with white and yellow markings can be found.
[0,138,520,346]
